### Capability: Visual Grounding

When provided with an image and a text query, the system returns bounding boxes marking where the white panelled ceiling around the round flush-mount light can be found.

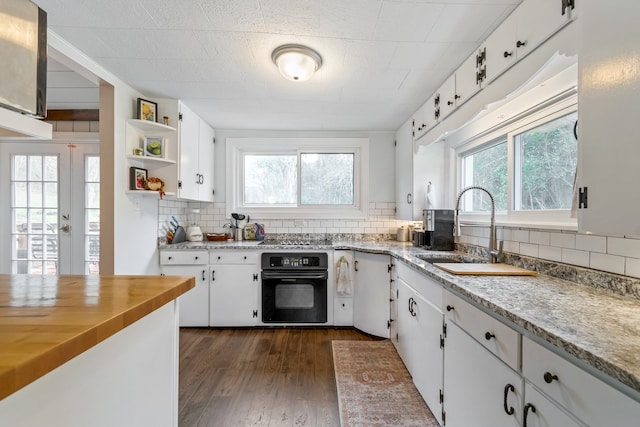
[34,0,522,130]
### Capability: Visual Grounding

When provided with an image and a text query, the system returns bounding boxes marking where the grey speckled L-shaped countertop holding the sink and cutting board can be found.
[160,241,640,399]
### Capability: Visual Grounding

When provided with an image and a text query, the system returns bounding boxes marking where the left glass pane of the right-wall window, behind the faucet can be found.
[463,141,508,211]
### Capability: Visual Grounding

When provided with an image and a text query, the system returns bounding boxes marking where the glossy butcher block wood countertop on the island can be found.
[0,275,195,399]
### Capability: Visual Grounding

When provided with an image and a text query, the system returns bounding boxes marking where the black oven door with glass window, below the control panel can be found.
[262,270,327,323]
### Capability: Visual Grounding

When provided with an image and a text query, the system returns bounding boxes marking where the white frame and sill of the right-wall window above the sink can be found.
[455,95,578,229]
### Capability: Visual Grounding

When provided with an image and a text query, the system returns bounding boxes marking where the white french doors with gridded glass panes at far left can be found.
[0,142,100,274]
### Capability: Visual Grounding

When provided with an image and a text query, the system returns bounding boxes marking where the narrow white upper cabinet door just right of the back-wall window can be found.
[396,119,414,221]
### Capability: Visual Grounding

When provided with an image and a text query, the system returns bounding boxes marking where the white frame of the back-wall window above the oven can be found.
[226,138,369,219]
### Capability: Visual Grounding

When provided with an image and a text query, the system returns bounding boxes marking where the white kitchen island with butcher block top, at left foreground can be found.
[0,275,194,426]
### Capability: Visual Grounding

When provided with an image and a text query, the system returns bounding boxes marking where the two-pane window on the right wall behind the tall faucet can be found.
[459,104,578,220]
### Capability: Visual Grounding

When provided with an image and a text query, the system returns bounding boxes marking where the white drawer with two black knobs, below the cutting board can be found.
[443,292,521,371]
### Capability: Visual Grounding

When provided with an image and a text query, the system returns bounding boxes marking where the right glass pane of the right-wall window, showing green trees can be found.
[515,113,578,210]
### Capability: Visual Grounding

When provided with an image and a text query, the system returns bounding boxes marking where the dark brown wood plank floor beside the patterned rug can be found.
[179,327,377,427]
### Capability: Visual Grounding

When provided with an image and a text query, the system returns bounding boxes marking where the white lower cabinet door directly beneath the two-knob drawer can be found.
[444,321,522,427]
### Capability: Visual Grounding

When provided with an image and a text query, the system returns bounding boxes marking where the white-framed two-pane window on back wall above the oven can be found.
[227,138,369,218]
